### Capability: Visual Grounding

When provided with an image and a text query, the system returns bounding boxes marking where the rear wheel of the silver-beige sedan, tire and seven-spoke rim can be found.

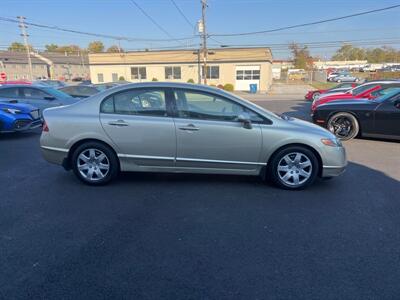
[72,142,119,185]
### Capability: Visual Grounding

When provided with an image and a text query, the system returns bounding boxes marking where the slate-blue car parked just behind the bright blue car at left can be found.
[0,85,78,112]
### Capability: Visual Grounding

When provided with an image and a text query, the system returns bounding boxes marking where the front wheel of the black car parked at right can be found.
[327,112,360,141]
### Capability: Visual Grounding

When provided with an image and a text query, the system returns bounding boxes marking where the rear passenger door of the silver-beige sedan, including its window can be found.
[100,88,176,169]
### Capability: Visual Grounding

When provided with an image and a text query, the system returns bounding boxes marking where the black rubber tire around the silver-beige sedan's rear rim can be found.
[71,142,119,185]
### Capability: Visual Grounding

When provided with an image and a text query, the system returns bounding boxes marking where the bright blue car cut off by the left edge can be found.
[0,102,42,133]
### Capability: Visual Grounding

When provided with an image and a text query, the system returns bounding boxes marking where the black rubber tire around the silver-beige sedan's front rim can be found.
[267,146,320,190]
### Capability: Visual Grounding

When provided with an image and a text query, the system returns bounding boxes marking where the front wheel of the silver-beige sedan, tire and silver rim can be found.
[268,146,319,190]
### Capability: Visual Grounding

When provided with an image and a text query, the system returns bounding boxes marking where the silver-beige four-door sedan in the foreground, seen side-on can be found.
[40,82,347,189]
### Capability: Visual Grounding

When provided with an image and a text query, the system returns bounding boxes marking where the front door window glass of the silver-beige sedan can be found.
[174,90,263,122]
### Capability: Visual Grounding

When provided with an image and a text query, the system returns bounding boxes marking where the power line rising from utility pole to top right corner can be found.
[210,4,400,36]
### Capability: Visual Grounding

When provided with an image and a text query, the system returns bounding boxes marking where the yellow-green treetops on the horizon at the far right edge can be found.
[332,45,400,63]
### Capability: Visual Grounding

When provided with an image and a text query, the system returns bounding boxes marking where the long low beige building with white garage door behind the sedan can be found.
[89,48,272,91]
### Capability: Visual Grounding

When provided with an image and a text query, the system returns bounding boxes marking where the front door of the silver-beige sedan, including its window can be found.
[173,89,263,172]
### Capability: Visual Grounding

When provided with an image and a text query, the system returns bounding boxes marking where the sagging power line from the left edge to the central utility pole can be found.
[0,17,196,42]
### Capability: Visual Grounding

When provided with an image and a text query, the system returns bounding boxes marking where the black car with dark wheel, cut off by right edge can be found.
[313,88,400,140]
